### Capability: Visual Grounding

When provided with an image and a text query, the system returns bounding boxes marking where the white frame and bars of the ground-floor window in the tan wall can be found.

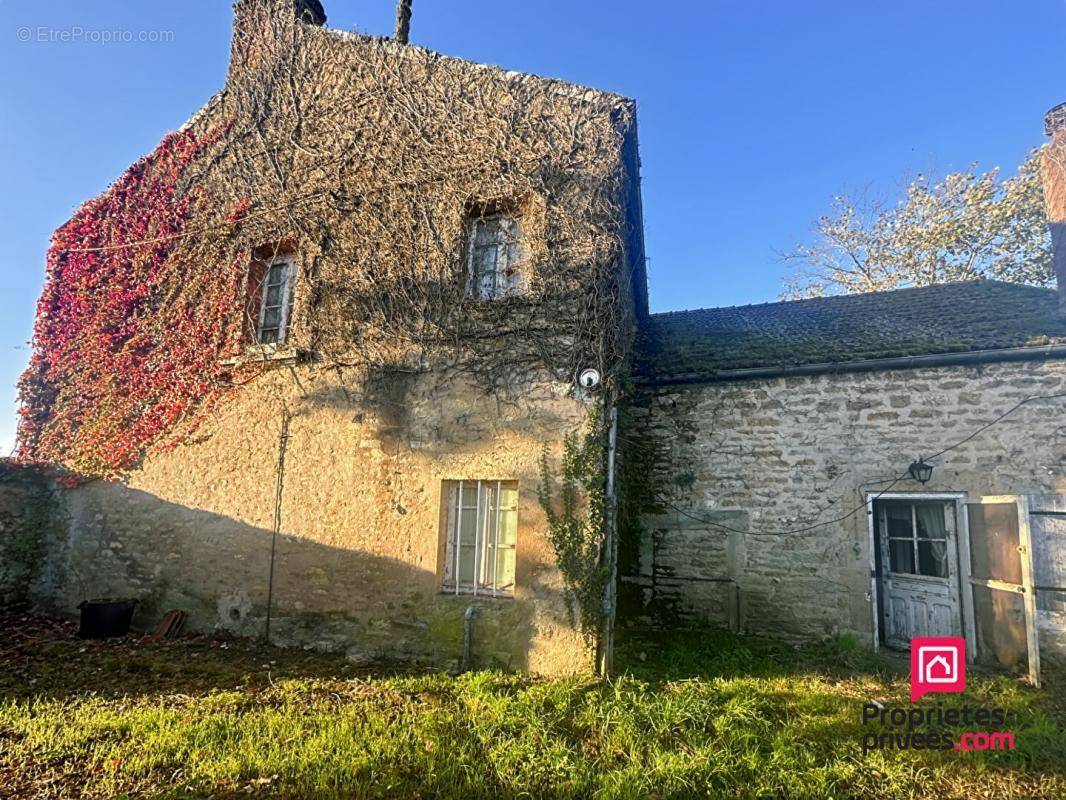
[439,478,519,598]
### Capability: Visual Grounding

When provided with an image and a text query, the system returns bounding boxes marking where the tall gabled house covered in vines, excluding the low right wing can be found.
[13,0,647,673]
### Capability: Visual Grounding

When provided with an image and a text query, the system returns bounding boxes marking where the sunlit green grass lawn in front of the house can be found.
[0,613,1066,799]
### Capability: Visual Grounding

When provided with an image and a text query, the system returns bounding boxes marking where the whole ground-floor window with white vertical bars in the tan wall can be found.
[443,480,518,597]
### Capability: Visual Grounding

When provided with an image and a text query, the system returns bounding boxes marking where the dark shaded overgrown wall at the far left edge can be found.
[0,459,52,604]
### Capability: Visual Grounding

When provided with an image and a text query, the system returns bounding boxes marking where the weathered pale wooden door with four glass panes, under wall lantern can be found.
[877,500,963,649]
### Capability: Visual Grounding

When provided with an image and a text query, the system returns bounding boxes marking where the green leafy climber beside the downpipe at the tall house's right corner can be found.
[537,410,609,644]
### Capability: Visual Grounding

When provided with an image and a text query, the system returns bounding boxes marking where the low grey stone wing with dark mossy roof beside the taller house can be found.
[623,281,1066,678]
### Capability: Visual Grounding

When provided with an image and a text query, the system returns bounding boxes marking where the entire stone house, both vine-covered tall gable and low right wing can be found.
[6,0,1066,676]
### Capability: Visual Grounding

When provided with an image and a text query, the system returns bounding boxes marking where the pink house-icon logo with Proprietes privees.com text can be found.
[862,637,1014,755]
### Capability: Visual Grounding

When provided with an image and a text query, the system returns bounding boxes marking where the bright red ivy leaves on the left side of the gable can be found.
[19,126,247,476]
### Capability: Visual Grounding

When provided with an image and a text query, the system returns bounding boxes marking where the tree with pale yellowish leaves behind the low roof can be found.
[784,150,1054,299]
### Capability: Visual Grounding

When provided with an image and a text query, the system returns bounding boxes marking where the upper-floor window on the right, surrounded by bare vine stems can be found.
[467,214,522,300]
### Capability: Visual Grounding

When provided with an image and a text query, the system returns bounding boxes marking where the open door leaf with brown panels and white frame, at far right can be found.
[966,495,1040,686]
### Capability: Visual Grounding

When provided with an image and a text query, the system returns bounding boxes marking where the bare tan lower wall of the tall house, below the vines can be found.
[37,367,592,673]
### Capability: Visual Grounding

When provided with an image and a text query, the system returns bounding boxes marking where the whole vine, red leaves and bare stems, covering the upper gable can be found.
[19,0,635,476]
